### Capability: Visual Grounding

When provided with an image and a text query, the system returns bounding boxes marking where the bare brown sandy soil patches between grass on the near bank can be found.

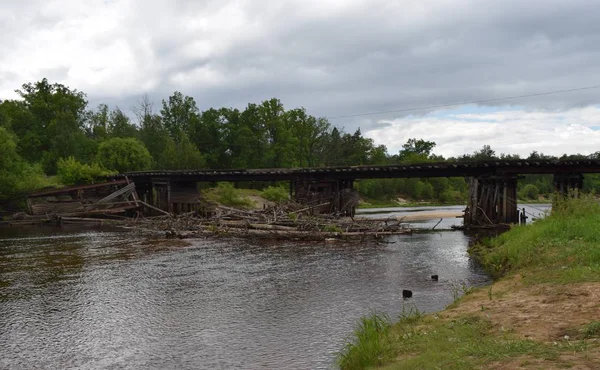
[440,275,600,370]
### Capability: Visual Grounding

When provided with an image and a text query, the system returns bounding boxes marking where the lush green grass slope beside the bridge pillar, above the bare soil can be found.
[470,196,600,284]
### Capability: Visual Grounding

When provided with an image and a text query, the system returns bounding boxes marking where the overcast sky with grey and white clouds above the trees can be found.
[0,0,600,156]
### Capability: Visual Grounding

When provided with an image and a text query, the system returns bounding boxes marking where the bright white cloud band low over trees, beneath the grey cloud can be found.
[364,106,600,157]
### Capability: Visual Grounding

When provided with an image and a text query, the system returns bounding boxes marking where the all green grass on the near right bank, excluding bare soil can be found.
[337,197,600,369]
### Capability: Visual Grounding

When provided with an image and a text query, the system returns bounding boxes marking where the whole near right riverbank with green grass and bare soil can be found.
[338,198,600,369]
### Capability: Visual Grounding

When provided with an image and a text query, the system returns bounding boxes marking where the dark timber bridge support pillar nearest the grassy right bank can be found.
[464,176,519,227]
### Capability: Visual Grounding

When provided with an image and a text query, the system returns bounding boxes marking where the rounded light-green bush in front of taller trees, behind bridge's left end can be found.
[96,138,152,173]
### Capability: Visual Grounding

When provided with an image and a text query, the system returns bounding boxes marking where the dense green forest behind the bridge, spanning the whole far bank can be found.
[0,79,600,205]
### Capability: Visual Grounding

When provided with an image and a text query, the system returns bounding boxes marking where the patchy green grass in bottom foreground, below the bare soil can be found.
[337,314,585,370]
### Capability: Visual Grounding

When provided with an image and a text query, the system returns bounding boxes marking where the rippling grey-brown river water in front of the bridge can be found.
[0,205,548,369]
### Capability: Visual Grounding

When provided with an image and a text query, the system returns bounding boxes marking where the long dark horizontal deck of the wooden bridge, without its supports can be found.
[115,159,600,182]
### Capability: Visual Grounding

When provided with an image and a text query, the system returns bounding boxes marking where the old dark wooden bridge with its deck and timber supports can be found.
[115,159,600,226]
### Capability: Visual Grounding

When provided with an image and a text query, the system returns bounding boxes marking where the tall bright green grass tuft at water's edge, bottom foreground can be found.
[336,313,394,370]
